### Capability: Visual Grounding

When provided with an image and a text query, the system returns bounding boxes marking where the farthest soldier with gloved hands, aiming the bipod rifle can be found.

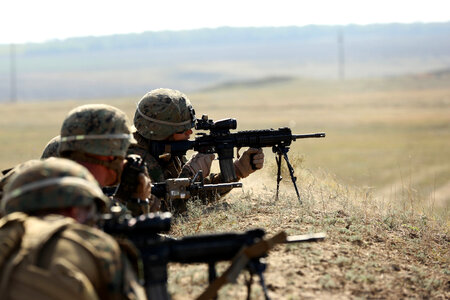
[128,89,264,210]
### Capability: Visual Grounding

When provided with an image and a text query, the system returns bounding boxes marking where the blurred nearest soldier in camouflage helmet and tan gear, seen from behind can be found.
[0,158,146,300]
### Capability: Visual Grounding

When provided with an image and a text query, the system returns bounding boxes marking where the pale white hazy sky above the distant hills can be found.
[0,0,450,44]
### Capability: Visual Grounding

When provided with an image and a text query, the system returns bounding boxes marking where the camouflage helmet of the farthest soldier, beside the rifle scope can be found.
[134,89,195,141]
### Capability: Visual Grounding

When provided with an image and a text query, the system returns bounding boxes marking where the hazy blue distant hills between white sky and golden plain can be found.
[0,23,450,101]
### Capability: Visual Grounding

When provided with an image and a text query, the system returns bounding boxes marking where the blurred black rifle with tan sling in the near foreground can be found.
[103,213,325,300]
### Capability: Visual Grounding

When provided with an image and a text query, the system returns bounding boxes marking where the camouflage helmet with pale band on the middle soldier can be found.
[59,104,135,157]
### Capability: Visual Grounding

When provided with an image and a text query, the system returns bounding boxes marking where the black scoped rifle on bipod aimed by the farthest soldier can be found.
[149,115,325,203]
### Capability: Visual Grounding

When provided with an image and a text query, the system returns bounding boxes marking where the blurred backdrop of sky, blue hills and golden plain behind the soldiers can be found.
[0,0,450,215]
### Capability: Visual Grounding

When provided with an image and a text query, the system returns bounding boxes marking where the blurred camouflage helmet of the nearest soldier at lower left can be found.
[2,158,109,213]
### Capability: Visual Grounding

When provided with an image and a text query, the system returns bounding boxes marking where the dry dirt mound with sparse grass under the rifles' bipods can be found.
[165,171,450,299]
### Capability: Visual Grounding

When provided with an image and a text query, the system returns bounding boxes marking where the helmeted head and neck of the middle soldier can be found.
[59,104,134,186]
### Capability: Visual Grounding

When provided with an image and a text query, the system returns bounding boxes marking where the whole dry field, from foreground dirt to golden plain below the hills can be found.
[0,74,450,299]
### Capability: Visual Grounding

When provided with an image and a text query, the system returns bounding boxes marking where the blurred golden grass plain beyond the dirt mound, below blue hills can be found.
[0,70,450,213]
